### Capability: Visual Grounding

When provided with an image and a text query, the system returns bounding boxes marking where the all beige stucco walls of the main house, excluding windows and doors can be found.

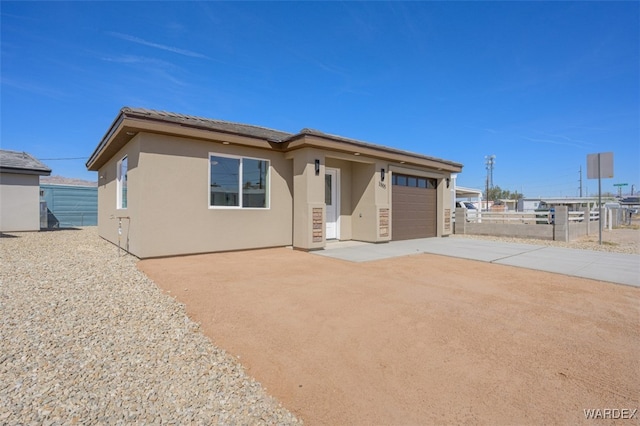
[98,133,452,258]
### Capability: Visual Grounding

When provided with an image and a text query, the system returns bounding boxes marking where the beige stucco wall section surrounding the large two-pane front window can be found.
[100,134,292,258]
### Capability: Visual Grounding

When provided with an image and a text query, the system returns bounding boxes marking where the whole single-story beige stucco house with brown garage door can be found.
[87,108,462,258]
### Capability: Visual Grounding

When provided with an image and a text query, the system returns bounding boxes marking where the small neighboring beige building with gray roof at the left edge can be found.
[0,149,51,232]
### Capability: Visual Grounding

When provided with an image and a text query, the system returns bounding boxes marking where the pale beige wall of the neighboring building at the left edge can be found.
[0,173,40,232]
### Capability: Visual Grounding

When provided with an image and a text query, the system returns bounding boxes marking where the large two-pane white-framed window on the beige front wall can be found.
[209,154,269,208]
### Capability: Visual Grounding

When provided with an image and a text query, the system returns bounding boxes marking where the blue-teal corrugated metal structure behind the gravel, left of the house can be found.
[40,183,98,228]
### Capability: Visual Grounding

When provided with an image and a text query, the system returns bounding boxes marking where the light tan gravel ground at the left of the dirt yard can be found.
[0,227,301,425]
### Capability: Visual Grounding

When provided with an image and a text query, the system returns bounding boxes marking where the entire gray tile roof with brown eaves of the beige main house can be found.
[86,107,462,172]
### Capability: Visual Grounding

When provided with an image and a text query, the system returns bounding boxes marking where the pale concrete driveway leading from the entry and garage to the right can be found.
[312,237,640,287]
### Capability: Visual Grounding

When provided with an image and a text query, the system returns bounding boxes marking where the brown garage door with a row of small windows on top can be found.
[391,173,438,240]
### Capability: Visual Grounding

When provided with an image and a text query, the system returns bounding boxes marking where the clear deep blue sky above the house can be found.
[0,1,640,197]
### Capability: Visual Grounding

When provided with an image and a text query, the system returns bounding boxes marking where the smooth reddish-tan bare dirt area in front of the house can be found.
[139,248,640,425]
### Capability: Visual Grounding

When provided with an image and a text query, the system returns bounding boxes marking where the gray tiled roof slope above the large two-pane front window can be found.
[121,107,292,142]
